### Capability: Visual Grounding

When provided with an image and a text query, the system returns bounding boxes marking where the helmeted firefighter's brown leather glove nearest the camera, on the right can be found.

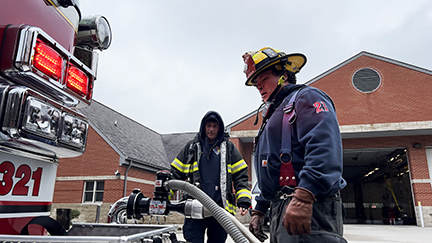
[283,187,316,235]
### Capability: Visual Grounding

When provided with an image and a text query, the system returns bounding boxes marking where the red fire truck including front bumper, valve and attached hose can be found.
[0,0,255,242]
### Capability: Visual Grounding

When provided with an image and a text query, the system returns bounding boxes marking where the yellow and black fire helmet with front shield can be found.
[243,47,306,86]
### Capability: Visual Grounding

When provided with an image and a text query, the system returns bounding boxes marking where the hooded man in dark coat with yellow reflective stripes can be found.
[171,111,251,243]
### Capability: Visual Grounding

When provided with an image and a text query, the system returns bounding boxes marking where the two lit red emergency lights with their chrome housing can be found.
[2,26,96,108]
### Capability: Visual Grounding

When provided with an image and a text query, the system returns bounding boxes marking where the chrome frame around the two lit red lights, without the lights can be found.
[5,27,96,108]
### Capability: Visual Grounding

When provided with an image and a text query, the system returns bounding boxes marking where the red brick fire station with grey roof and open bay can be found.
[53,52,432,226]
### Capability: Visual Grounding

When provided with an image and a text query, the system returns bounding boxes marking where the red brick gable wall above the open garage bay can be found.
[311,56,432,125]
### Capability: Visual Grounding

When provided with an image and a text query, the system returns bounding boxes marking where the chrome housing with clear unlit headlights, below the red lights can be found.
[0,86,89,158]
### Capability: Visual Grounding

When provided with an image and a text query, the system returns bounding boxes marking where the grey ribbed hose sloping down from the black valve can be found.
[166,180,248,243]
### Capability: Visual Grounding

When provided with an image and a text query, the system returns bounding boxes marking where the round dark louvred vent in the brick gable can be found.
[352,68,381,93]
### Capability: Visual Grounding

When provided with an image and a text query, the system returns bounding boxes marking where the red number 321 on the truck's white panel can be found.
[0,161,42,196]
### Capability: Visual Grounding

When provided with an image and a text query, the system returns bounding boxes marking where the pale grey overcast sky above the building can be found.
[80,0,432,134]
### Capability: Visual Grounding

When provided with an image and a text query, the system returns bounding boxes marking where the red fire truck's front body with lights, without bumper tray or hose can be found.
[0,0,111,235]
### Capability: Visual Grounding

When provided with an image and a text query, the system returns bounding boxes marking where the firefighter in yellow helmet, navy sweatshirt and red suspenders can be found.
[243,47,346,243]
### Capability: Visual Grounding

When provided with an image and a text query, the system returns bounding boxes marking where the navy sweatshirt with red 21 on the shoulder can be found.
[255,84,346,212]
